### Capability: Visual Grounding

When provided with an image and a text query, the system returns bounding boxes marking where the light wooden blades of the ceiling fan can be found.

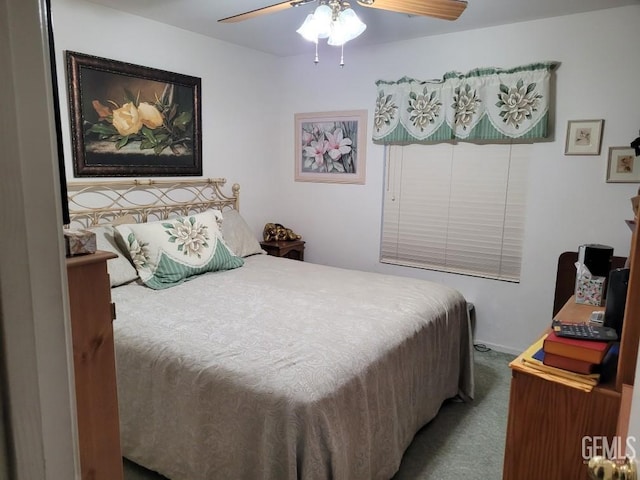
[218,0,467,23]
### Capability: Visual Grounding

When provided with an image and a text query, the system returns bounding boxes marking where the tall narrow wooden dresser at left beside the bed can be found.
[67,252,123,480]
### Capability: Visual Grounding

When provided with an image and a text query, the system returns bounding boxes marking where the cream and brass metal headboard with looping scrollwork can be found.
[67,178,240,228]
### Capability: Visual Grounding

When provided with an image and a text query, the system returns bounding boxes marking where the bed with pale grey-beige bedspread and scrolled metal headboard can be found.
[68,179,473,480]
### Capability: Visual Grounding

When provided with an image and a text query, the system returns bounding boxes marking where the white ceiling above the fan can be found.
[82,0,640,56]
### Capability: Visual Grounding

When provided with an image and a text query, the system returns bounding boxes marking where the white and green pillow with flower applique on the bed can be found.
[115,210,244,290]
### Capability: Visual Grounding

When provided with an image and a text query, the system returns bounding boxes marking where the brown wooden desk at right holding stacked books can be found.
[503,215,640,480]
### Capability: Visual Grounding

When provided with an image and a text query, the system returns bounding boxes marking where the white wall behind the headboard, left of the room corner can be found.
[52,0,278,228]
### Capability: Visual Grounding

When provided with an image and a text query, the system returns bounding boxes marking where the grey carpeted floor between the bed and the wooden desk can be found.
[124,351,514,480]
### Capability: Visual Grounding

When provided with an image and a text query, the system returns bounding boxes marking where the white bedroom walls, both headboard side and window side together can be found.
[53,0,640,352]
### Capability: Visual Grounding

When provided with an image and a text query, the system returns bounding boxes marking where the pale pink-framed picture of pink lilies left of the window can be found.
[294,110,367,184]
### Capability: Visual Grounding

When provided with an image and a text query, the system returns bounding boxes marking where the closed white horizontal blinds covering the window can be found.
[380,144,530,282]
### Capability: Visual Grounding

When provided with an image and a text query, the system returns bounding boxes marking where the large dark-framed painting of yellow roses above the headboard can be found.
[66,52,202,177]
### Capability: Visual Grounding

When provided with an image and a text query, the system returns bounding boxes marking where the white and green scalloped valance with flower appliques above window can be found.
[373,62,558,144]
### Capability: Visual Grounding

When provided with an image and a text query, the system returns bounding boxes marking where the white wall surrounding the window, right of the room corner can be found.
[274,5,640,352]
